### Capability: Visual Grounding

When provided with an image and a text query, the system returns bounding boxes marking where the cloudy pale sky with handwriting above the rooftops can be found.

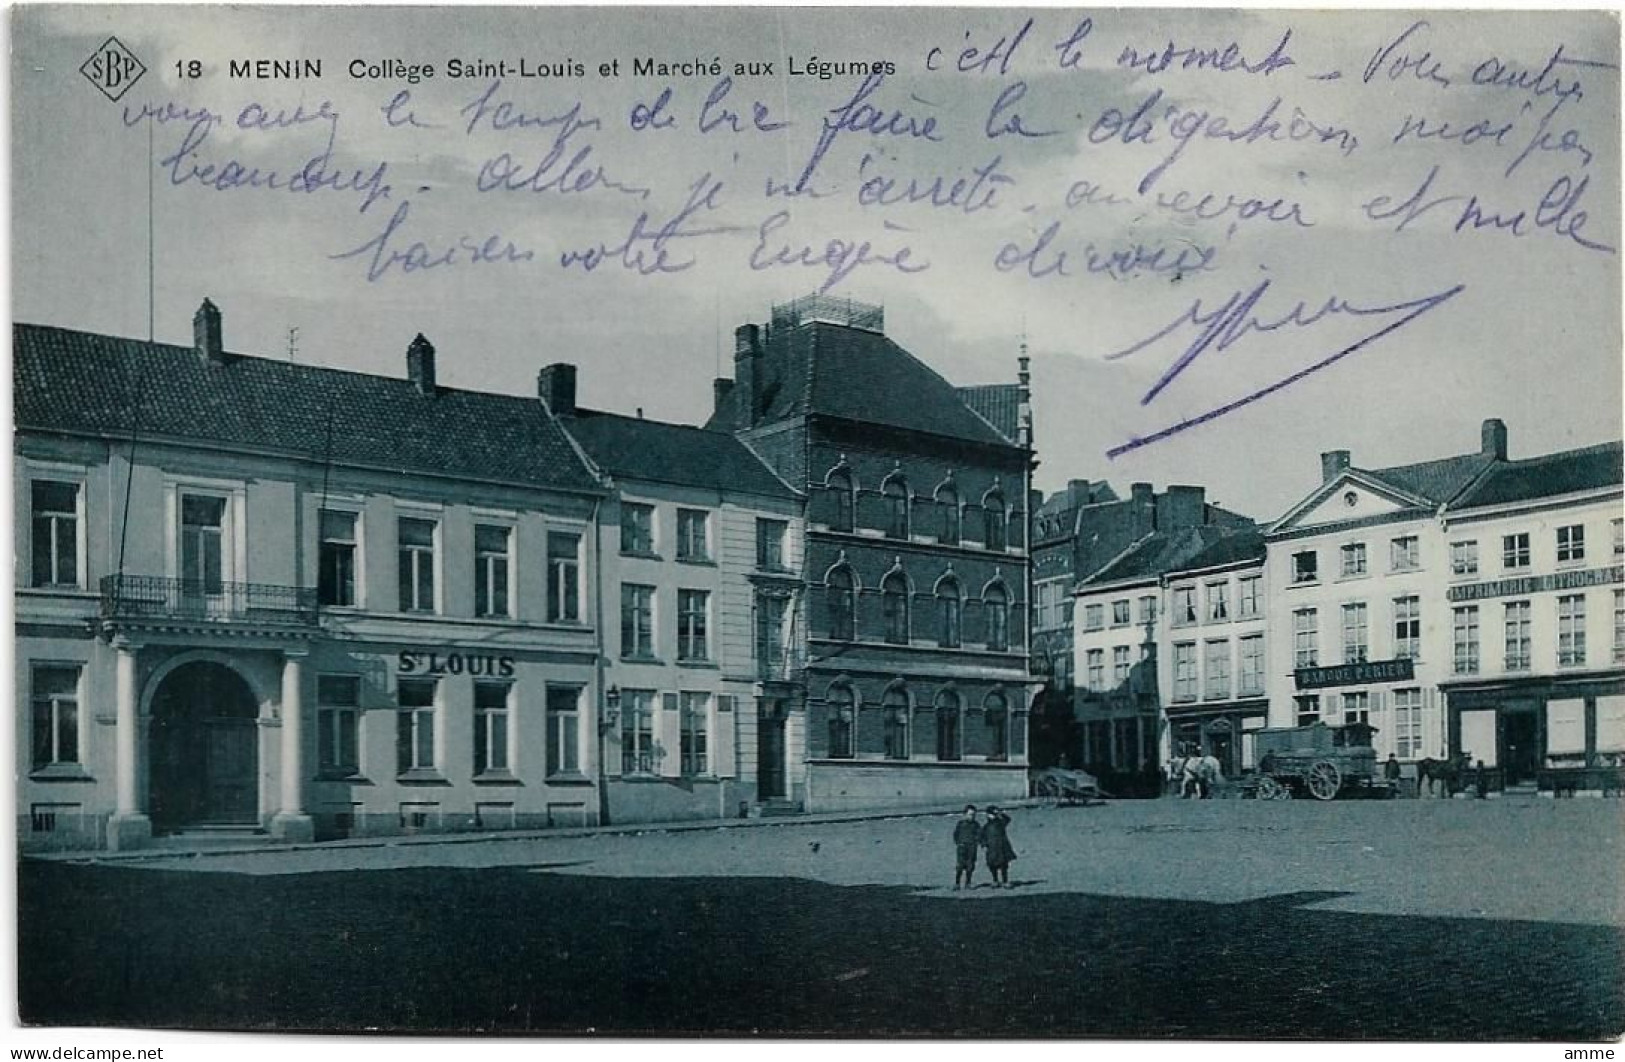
[11,6,1622,520]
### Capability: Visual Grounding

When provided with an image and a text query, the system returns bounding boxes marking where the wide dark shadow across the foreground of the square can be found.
[18,861,1625,1041]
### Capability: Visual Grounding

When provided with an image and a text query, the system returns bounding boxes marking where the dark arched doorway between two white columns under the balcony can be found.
[148,661,260,833]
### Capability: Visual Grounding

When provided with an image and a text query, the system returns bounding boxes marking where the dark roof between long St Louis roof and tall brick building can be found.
[564,409,796,499]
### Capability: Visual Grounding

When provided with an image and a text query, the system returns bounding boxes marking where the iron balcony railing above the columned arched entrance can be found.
[101,575,317,625]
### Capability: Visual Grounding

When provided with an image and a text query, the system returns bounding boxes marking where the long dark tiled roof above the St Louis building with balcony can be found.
[11,325,600,490]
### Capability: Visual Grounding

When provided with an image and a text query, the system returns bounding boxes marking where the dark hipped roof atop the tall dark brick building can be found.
[709,322,1012,447]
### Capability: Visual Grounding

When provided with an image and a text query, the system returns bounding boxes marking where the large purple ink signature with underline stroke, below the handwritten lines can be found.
[1107,279,1467,458]
